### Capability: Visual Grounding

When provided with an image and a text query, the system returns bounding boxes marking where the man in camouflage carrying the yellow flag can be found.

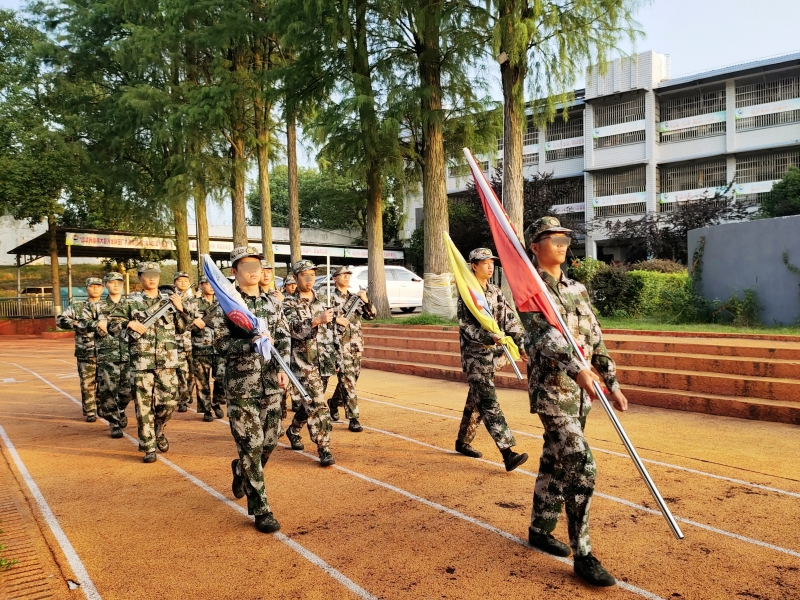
[456,248,528,471]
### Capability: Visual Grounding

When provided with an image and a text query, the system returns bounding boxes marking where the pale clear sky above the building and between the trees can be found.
[6,0,800,225]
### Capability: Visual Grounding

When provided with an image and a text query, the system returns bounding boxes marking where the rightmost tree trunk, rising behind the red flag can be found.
[500,0,528,241]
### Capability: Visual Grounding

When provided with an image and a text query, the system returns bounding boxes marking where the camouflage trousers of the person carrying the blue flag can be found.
[228,394,281,515]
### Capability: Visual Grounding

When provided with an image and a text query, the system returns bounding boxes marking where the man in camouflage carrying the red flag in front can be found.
[522,217,628,586]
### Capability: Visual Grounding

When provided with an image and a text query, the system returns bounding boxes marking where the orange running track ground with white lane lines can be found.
[0,338,800,600]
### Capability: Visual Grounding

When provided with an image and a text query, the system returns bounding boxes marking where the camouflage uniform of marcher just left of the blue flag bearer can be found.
[187,296,225,414]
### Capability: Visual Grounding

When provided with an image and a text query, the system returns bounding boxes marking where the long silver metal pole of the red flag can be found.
[464,148,684,540]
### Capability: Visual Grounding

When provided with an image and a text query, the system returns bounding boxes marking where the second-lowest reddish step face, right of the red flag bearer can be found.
[617,365,800,403]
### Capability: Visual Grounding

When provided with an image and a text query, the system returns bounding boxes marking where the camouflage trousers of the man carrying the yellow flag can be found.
[458,373,517,450]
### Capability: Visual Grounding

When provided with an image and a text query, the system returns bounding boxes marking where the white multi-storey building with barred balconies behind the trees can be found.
[407,51,800,259]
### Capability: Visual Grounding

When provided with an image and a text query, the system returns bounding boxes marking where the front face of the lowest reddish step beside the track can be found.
[362,357,800,425]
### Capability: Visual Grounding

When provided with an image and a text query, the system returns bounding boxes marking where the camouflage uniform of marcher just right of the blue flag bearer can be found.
[283,261,341,454]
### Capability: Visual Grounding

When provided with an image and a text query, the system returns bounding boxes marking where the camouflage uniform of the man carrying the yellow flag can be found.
[457,283,525,450]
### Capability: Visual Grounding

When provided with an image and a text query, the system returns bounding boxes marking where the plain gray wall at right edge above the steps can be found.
[688,215,800,325]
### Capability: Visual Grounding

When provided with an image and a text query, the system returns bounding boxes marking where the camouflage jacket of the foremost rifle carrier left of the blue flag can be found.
[108,293,187,371]
